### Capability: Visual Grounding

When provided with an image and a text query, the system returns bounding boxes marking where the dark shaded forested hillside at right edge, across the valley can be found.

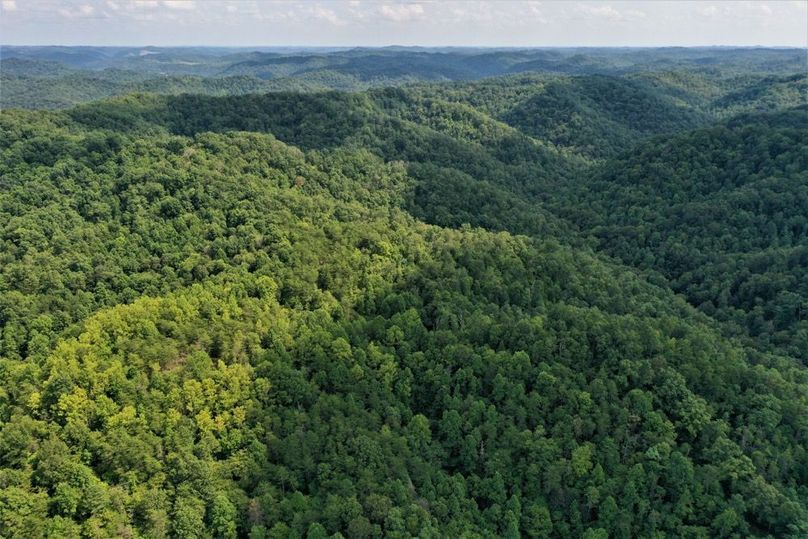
[559,107,808,361]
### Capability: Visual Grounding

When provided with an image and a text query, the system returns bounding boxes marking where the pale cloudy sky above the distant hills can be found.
[0,0,808,47]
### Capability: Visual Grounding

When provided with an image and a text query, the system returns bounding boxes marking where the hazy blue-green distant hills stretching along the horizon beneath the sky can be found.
[0,45,805,109]
